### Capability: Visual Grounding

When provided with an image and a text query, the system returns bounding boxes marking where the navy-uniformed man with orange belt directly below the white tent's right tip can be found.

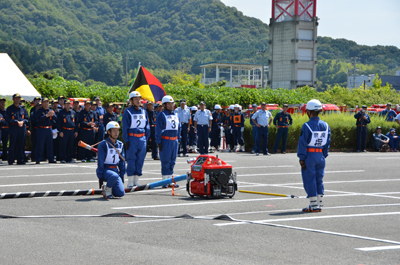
[35,98,57,164]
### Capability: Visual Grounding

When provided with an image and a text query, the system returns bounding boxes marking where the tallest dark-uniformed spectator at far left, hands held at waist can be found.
[6,93,29,165]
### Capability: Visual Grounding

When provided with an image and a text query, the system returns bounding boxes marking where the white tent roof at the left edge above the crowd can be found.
[0,53,40,100]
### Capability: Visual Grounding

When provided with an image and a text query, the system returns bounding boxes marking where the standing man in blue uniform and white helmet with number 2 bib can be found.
[122,91,150,189]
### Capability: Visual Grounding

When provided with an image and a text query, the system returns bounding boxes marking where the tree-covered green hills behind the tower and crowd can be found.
[0,0,400,86]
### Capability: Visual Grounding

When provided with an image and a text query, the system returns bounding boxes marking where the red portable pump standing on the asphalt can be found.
[186,155,237,198]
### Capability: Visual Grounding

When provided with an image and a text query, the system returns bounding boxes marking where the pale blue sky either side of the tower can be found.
[221,0,400,48]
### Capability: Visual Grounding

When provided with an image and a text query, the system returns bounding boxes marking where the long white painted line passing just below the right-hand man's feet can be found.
[214,210,400,226]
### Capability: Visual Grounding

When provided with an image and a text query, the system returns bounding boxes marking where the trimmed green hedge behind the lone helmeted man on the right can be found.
[243,113,399,151]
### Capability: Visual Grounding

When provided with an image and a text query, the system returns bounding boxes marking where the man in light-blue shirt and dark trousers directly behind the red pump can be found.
[193,101,213,155]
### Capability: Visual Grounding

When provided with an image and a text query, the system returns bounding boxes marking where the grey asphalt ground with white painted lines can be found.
[0,152,400,264]
